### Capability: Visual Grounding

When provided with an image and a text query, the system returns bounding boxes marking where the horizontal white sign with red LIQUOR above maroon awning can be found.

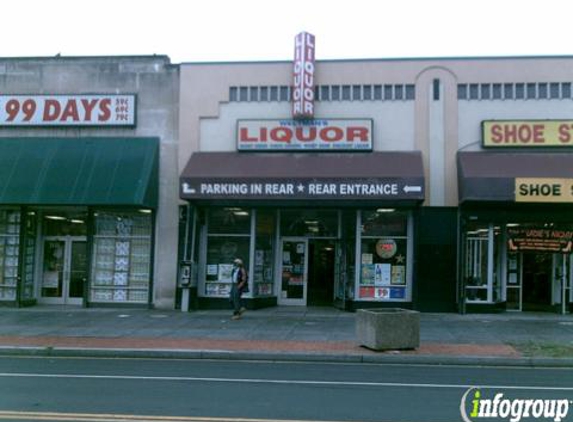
[237,119,372,152]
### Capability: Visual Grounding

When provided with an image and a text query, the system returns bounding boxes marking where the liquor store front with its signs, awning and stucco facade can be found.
[179,34,455,309]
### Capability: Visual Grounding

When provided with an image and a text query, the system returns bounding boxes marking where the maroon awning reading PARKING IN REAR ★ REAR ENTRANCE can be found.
[180,151,424,202]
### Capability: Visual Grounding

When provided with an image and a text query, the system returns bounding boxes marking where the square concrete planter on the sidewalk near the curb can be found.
[356,308,420,350]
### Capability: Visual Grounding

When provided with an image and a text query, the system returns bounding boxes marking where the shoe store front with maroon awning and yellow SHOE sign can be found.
[458,138,573,313]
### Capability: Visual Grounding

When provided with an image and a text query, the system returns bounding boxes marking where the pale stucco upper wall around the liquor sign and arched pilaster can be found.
[179,57,573,206]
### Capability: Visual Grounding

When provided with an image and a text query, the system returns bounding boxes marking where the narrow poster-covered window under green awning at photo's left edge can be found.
[0,210,20,301]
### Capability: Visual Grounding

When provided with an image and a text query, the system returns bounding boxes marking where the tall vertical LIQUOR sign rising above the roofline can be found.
[292,32,315,119]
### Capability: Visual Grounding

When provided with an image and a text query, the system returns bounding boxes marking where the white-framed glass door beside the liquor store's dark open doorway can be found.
[278,237,308,306]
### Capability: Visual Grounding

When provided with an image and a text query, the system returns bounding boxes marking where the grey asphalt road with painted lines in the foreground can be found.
[0,357,573,422]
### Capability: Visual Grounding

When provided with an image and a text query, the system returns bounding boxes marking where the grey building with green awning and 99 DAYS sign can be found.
[0,56,178,308]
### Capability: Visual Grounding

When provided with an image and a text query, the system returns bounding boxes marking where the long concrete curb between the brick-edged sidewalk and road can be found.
[0,346,573,368]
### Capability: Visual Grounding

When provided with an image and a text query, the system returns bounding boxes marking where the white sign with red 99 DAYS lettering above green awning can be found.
[0,94,135,126]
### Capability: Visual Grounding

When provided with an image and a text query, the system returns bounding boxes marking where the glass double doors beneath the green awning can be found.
[40,236,87,305]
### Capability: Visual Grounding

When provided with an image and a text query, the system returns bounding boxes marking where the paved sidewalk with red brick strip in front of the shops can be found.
[0,306,573,367]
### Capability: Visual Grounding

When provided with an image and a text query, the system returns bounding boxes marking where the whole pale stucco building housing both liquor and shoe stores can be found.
[179,43,573,312]
